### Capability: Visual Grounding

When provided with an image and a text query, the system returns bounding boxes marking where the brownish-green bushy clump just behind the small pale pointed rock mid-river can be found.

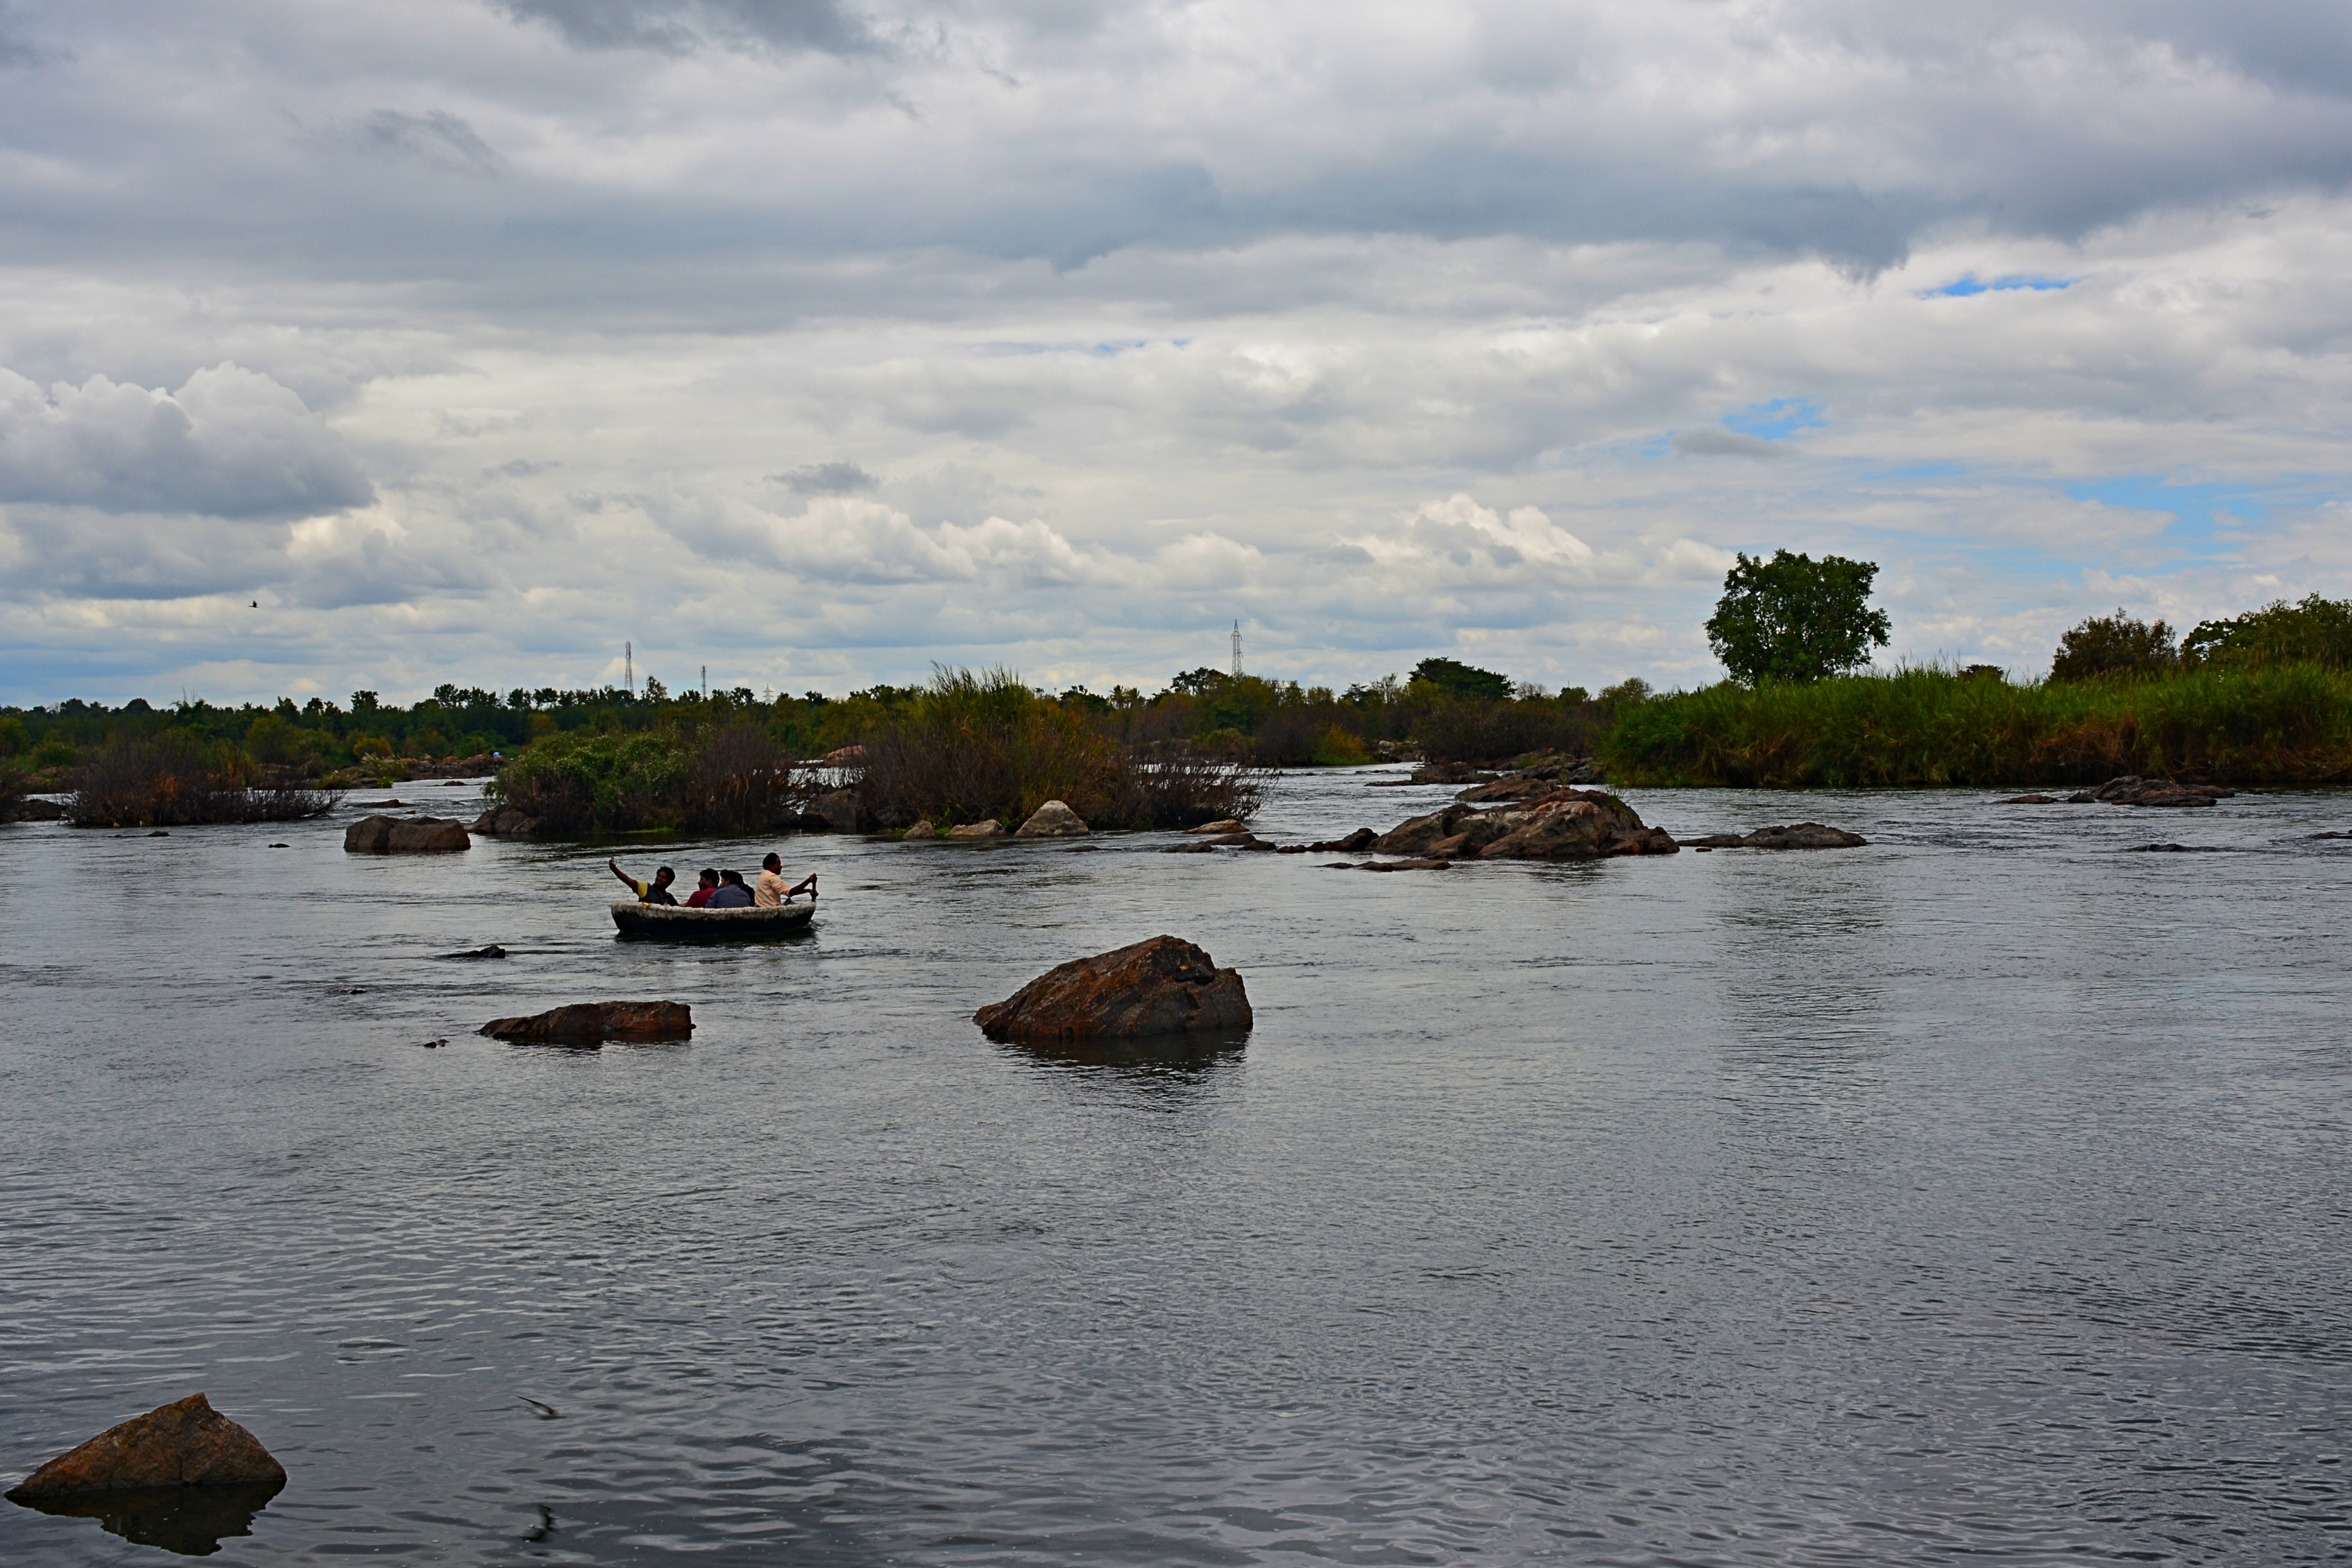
[858,670,1263,828]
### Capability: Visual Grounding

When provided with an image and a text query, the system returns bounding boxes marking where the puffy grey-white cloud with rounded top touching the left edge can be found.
[0,364,374,520]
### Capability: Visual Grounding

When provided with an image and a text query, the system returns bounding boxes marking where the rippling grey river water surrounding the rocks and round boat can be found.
[0,771,2352,1566]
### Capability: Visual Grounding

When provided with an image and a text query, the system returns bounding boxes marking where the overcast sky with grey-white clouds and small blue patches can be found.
[0,0,2352,703]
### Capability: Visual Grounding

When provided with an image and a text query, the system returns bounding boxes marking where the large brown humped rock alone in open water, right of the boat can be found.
[971,936,1254,1039]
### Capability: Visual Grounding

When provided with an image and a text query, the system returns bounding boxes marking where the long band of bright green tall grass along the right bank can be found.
[1599,665,2352,787]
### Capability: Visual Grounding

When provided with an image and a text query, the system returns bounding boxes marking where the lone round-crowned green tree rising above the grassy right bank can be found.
[1707,550,1891,686]
